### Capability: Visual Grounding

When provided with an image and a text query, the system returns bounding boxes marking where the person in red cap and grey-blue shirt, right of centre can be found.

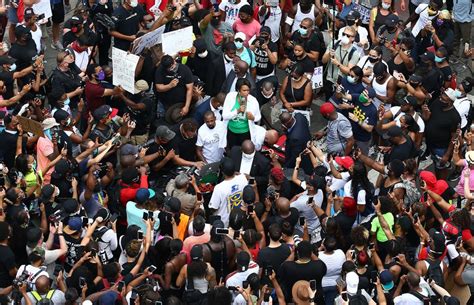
[315,102,354,156]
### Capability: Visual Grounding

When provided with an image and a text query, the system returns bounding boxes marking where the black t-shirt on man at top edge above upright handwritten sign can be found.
[112,5,145,51]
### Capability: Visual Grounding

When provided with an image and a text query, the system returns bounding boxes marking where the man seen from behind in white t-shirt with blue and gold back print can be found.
[209,158,248,227]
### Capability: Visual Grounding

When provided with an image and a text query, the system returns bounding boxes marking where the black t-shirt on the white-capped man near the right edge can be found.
[425,99,461,148]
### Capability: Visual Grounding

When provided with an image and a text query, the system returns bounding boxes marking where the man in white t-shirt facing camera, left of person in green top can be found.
[196,110,227,163]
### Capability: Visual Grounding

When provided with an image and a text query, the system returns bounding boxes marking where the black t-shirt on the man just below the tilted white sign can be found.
[155,64,193,108]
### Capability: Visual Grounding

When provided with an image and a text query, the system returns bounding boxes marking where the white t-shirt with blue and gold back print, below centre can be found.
[209,175,248,227]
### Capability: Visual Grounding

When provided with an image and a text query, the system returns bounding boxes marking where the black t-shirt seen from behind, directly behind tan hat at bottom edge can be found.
[279,260,327,304]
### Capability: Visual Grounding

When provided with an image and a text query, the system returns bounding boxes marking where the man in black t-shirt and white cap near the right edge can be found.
[421,88,461,179]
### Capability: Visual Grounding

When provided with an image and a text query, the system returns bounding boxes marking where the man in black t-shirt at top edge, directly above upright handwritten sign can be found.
[110,0,145,51]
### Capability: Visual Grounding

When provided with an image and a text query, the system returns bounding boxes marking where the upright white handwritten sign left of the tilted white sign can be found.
[112,48,139,93]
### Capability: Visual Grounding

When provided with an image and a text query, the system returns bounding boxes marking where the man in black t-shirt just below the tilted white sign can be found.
[155,55,193,116]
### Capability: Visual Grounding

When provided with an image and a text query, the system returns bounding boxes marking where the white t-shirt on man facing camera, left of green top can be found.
[196,121,227,163]
